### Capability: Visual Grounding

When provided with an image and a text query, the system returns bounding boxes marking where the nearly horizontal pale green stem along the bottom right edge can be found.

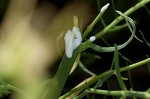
[86,88,150,99]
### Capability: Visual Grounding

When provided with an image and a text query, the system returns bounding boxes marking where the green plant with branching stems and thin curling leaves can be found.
[0,0,150,99]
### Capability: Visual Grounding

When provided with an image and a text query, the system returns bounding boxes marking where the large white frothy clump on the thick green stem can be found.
[64,26,82,58]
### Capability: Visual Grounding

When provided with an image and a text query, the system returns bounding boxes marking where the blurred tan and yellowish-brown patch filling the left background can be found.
[0,0,95,99]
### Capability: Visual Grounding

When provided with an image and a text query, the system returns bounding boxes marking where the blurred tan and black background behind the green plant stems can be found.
[0,0,150,99]
